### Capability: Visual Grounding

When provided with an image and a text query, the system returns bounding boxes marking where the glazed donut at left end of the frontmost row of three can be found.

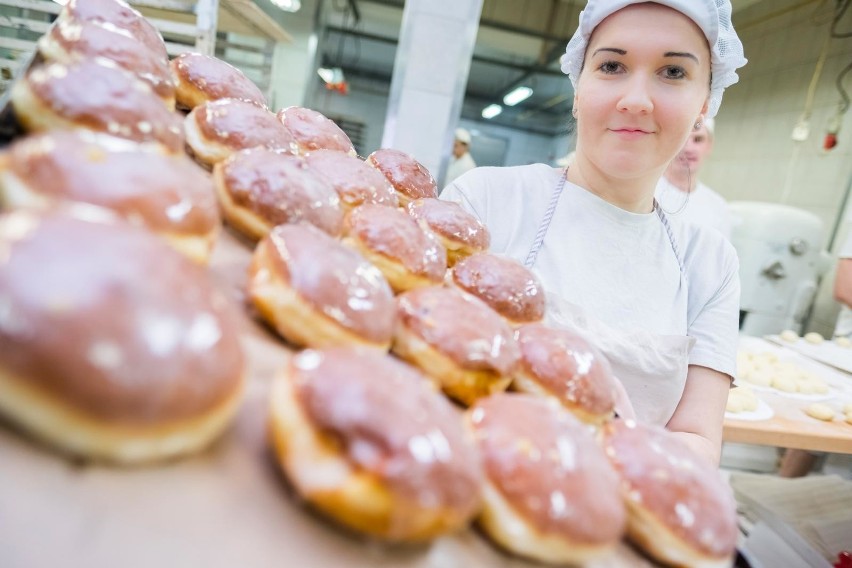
[270,348,482,541]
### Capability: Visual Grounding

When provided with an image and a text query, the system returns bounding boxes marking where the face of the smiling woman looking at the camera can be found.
[574,3,710,178]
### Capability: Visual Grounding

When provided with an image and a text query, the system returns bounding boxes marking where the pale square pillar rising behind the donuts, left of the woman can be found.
[382,0,482,179]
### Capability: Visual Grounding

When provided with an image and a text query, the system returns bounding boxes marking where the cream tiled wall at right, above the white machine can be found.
[702,0,852,335]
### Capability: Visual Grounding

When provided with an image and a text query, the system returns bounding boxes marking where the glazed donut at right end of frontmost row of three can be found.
[603,420,738,567]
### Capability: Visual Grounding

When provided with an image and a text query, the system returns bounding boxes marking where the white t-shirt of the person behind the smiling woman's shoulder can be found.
[655,177,731,240]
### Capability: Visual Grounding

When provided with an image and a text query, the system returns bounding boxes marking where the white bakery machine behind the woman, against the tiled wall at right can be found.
[729,201,830,336]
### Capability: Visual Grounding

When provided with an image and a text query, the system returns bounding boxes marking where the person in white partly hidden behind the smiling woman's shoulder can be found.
[656,118,731,240]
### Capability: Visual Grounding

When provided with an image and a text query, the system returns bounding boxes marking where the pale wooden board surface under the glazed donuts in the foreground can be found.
[0,230,653,568]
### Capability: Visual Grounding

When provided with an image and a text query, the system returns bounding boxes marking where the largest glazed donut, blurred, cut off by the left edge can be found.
[0,204,244,464]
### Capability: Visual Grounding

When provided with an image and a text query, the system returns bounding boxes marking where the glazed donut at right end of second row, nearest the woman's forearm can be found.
[512,323,616,424]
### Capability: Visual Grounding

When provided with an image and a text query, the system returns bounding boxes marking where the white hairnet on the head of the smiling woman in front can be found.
[561,0,748,118]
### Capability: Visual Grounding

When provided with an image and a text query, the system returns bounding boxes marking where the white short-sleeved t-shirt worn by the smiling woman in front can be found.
[441,164,740,378]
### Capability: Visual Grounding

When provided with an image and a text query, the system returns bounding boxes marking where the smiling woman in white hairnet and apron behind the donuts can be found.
[442,0,745,463]
